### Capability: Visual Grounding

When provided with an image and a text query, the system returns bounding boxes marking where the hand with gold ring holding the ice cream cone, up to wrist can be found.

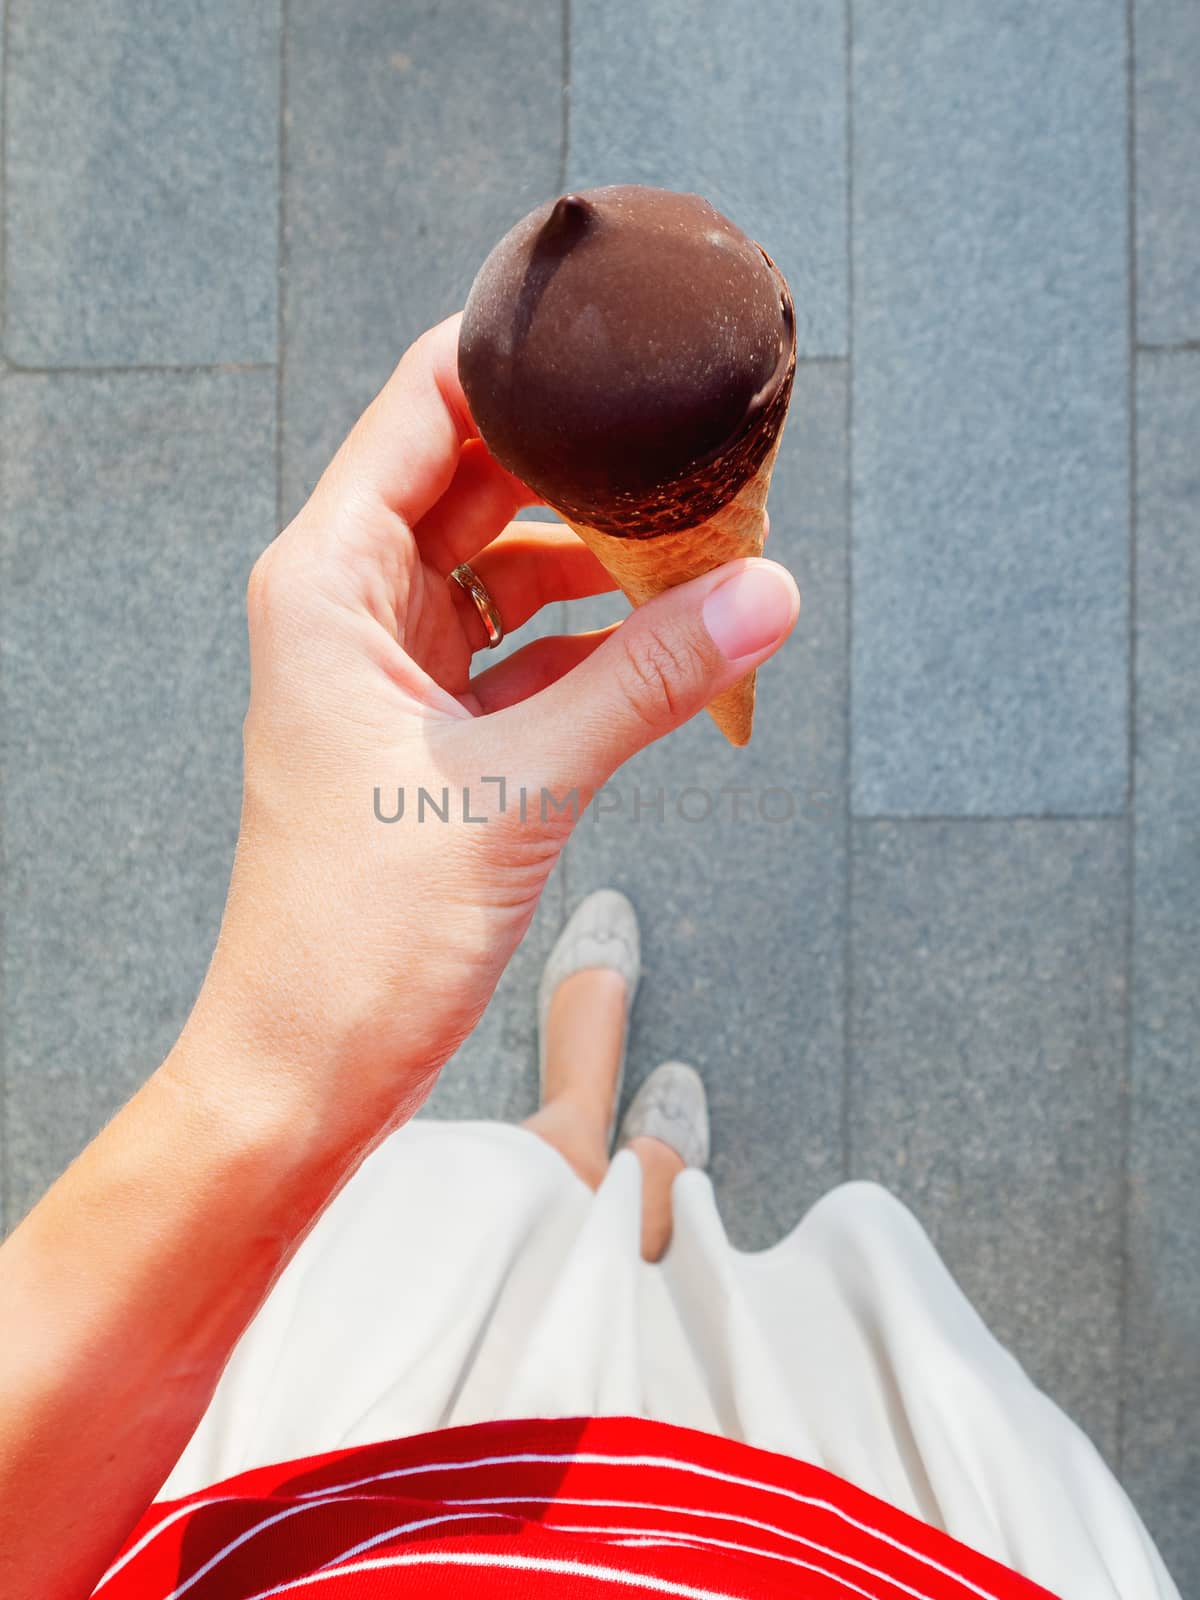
[189,308,800,1136]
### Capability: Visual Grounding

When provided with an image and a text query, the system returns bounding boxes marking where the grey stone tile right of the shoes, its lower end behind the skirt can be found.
[850,821,1126,1462]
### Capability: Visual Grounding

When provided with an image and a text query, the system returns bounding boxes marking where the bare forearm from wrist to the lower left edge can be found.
[0,998,401,1600]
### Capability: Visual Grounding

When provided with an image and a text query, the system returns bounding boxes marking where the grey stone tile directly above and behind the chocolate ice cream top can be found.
[568,0,848,355]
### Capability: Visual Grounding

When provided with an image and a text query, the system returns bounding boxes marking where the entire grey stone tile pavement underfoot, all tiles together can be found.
[0,0,1200,1592]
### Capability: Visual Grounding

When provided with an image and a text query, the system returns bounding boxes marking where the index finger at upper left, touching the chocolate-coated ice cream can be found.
[331,312,478,528]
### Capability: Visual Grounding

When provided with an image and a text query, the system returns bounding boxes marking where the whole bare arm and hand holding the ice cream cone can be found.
[0,318,809,1600]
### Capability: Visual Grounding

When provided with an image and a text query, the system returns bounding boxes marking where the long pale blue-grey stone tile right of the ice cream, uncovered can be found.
[853,0,1130,816]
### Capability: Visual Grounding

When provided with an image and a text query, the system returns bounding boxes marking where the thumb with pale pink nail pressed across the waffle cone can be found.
[525,557,800,792]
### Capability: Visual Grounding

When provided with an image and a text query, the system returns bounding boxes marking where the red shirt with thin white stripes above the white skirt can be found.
[93,1418,1046,1600]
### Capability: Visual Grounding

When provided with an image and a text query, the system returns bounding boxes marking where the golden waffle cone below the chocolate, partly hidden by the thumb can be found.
[560,429,782,744]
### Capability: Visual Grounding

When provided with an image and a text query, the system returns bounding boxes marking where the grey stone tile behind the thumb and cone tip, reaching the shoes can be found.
[566,363,846,1248]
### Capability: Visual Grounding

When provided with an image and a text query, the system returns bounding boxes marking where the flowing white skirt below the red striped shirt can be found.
[157,1118,1178,1600]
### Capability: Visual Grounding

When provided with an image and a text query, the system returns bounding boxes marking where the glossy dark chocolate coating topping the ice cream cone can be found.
[459,186,795,538]
